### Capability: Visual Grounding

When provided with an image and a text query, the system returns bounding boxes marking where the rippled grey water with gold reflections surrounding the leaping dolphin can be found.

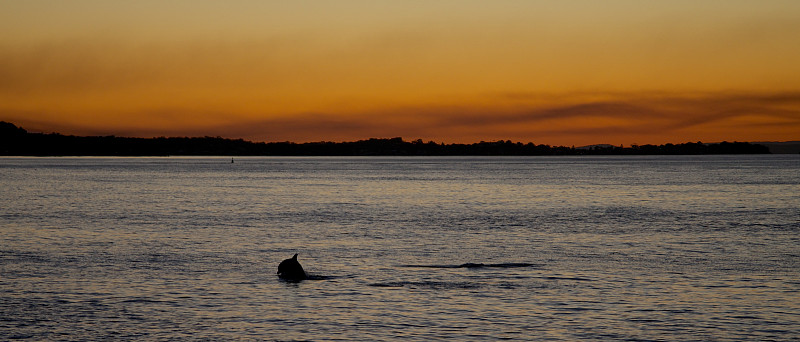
[0,155,800,341]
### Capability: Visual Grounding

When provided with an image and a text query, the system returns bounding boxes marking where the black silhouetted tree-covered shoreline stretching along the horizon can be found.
[0,121,780,156]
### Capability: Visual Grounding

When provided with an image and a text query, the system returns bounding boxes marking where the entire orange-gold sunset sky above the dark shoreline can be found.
[0,0,800,146]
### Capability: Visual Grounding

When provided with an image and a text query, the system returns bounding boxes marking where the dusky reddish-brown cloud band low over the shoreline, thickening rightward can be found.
[166,93,800,144]
